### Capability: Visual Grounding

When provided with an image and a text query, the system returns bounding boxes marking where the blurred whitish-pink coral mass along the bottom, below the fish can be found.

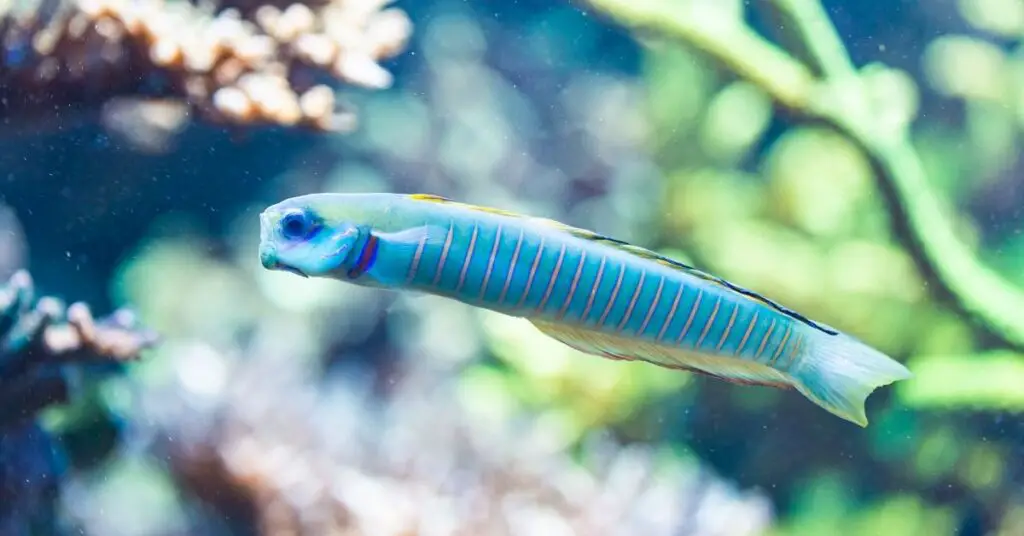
[72,332,772,536]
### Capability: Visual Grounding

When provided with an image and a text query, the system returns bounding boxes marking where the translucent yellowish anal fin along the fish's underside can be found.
[530,320,792,388]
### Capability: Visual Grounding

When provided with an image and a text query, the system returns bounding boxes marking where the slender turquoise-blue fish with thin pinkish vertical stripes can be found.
[259,193,912,426]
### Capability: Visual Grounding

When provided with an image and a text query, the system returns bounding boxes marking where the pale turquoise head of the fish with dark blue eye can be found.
[259,196,362,277]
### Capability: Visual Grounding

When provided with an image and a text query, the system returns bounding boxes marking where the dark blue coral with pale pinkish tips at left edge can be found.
[0,271,156,534]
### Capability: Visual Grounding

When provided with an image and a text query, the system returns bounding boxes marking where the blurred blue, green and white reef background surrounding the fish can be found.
[0,0,1024,536]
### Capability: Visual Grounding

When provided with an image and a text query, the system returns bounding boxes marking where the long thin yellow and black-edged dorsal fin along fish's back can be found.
[410,194,839,335]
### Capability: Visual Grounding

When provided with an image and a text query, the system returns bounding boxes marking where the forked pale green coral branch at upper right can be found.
[587,0,1024,348]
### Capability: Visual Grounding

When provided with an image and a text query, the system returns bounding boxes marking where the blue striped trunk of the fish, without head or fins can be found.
[395,200,804,373]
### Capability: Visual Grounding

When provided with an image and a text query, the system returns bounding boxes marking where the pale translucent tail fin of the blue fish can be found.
[788,333,913,426]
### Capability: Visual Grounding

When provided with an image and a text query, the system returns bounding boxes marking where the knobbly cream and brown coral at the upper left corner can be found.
[0,0,412,146]
